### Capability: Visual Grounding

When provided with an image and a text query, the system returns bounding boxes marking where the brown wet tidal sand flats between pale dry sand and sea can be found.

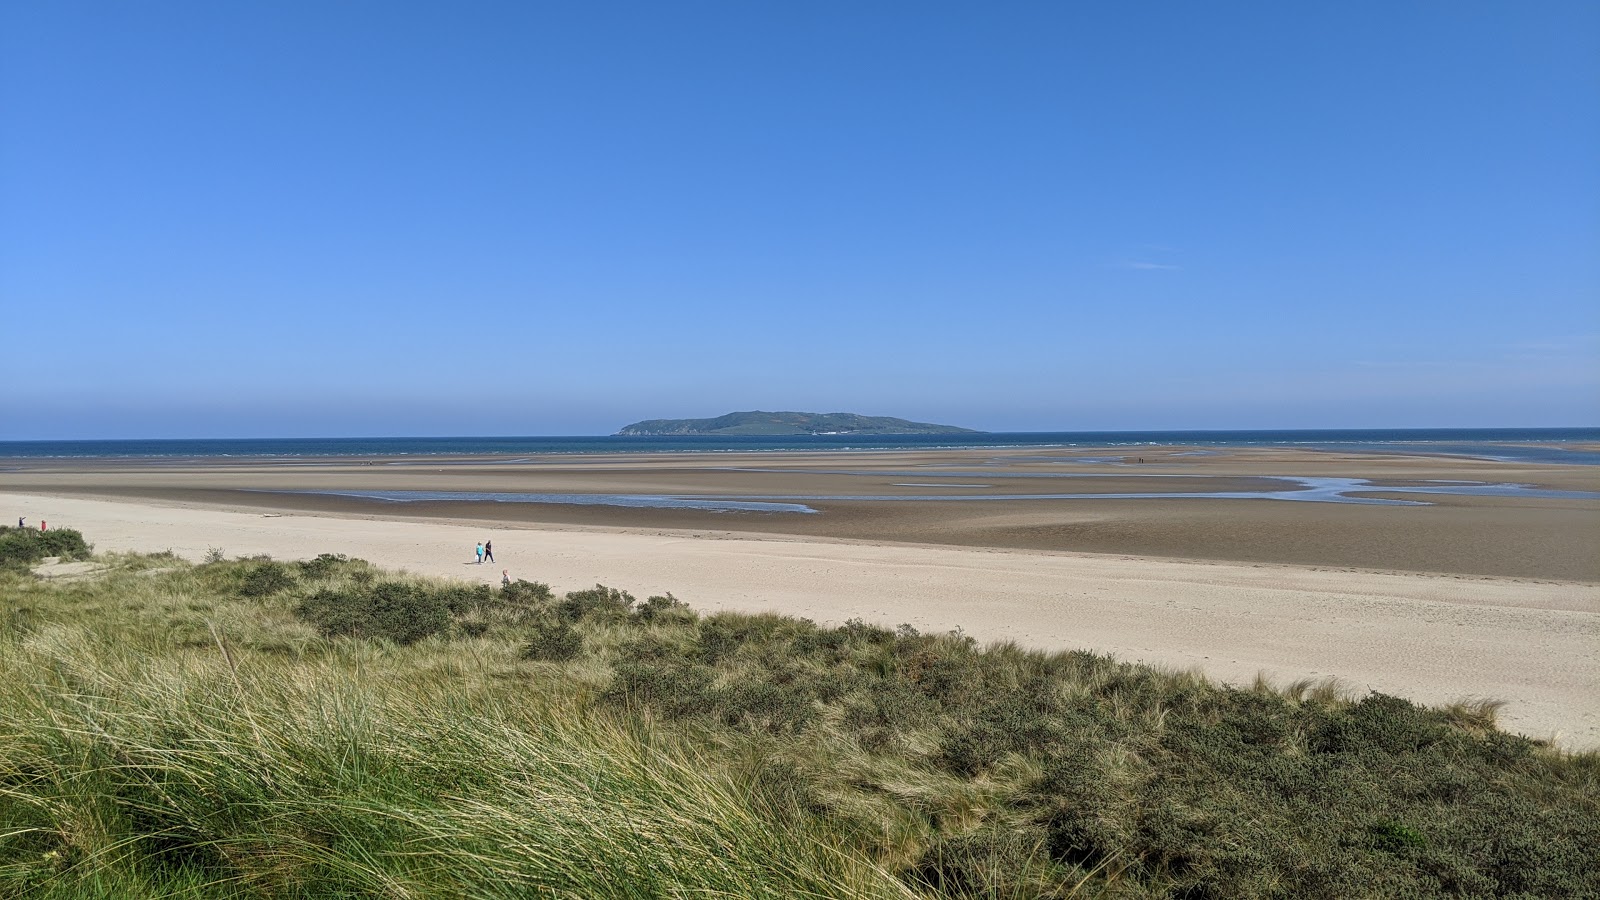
[0,447,1600,581]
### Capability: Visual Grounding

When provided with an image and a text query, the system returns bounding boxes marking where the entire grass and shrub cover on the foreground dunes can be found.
[0,533,1600,898]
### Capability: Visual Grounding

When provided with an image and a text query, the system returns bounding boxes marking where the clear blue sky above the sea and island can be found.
[0,0,1600,439]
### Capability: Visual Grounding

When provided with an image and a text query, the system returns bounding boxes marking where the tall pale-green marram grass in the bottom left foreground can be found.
[0,628,906,897]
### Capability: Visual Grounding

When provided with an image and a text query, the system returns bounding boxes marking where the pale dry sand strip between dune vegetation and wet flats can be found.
[0,492,1600,748]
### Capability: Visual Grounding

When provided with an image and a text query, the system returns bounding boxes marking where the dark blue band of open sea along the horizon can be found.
[0,428,1600,466]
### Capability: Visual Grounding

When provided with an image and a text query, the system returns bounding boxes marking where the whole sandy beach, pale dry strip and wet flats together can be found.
[0,448,1600,748]
